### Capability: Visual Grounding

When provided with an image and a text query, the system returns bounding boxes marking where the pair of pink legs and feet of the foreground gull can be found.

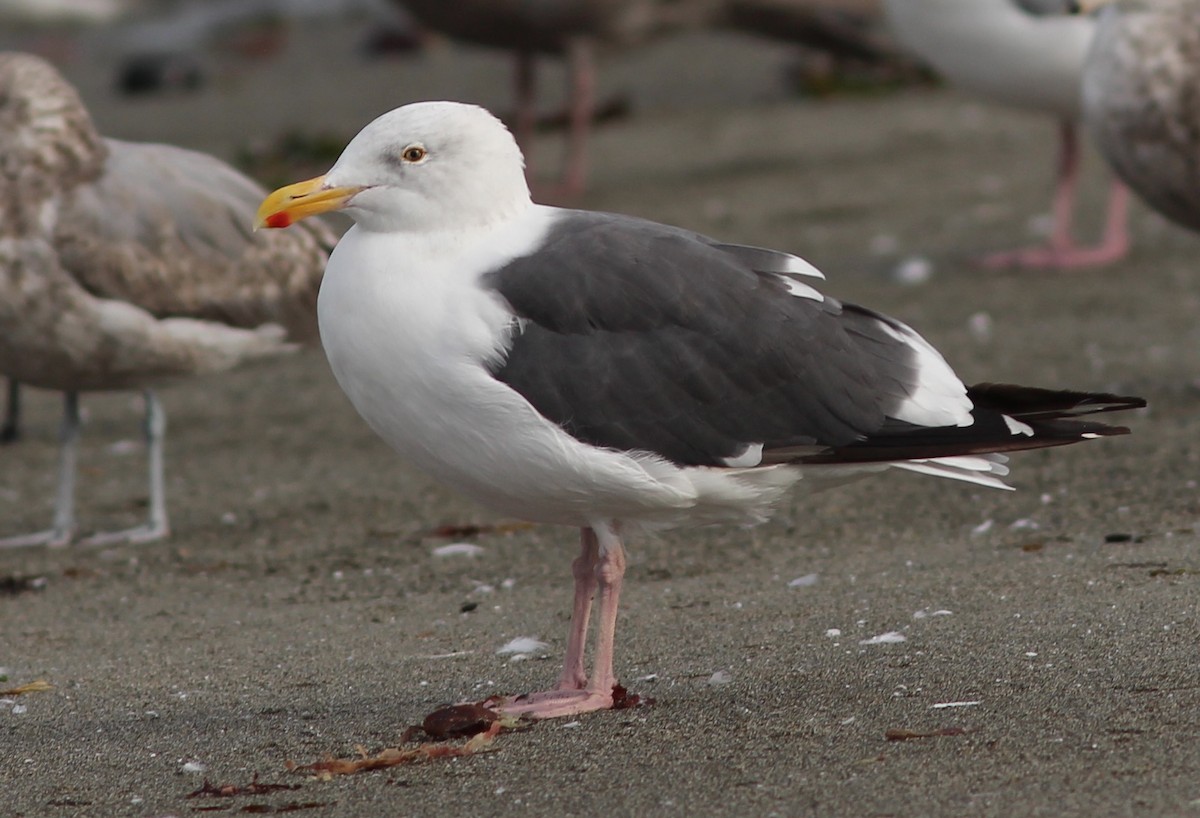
[499,527,625,718]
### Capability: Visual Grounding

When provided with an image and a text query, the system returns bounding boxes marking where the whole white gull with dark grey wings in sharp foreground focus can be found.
[258,102,1145,717]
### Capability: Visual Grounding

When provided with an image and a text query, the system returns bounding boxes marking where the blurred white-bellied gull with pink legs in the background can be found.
[883,0,1129,269]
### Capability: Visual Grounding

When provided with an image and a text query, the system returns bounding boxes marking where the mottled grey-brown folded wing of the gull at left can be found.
[54,139,334,339]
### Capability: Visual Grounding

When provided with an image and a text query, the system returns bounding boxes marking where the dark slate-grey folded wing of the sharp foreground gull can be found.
[485,212,940,465]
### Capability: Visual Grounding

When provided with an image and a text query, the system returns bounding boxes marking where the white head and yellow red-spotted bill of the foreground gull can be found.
[257,102,529,233]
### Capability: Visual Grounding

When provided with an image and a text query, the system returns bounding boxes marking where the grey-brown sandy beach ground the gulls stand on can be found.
[0,17,1200,817]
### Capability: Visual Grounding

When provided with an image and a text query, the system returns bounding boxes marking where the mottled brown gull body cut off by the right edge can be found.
[1084,0,1200,230]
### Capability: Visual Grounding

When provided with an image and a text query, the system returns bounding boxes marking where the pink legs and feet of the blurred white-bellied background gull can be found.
[982,121,1129,270]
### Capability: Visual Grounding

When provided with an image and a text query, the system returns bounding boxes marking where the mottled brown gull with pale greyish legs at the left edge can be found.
[0,53,334,547]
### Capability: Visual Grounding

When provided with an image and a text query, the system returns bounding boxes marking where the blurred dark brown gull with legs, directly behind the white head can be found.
[401,0,715,198]
